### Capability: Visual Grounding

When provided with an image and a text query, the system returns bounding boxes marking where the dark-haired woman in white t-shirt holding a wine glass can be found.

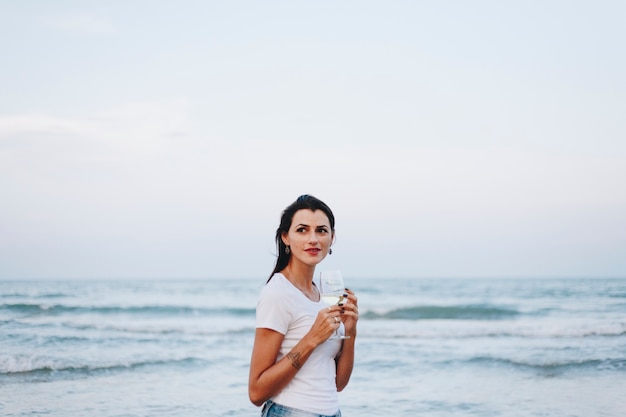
[248,195,359,417]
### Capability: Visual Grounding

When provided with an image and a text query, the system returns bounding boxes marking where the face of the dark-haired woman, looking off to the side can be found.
[282,209,333,266]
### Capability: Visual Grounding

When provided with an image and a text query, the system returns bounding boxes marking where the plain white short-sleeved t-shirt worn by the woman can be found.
[256,273,344,415]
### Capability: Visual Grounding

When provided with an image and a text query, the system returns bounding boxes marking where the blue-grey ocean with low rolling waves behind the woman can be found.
[0,272,626,417]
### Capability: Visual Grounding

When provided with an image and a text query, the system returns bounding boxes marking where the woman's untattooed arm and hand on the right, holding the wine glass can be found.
[335,289,359,391]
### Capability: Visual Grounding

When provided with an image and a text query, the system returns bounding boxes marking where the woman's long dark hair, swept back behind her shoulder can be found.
[267,194,335,282]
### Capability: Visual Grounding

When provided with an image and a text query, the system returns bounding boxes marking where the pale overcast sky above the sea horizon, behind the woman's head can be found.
[0,0,626,279]
